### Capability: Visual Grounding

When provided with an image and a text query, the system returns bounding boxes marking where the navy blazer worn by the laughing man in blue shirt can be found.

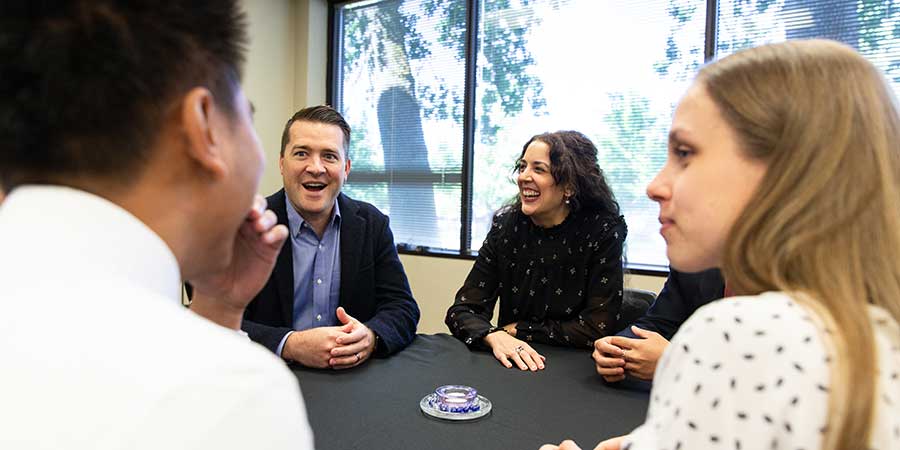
[241,189,419,356]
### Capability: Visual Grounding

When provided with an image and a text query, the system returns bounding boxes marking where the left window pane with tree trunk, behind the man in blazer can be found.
[334,0,466,251]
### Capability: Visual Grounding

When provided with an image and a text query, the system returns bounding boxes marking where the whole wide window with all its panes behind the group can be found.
[330,0,900,270]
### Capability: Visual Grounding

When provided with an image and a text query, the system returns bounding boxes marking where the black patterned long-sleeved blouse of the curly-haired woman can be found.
[445,208,627,348]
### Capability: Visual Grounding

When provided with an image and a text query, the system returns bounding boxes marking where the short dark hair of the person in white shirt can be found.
[0,0,247,186]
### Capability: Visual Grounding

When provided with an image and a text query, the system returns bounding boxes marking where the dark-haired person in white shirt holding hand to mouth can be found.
[0,0,313,450]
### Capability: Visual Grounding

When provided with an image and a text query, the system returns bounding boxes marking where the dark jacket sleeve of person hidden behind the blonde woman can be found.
[618,269,725,341]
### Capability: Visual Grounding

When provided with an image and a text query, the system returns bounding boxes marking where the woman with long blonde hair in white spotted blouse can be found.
[542,41,900,450]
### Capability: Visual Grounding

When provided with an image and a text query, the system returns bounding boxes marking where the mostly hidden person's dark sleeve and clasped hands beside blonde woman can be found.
[593,268,725,382]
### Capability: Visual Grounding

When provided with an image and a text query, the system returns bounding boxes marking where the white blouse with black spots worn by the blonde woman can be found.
[622,292,900,450]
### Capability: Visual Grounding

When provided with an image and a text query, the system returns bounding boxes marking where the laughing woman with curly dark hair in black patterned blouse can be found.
[445,131,627,371]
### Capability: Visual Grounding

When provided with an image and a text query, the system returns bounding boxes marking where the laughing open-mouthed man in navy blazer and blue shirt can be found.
[242,106,419,369]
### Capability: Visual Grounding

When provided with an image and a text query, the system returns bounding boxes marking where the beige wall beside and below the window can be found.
[244,0,665,333]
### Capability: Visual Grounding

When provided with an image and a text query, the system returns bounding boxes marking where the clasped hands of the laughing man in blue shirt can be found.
[281,307,375,370]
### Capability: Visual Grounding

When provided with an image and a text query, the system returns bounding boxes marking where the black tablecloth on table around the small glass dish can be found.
[292,334,648,450]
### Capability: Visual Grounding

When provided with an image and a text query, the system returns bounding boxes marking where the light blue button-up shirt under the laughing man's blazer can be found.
[276,197,341,356]
